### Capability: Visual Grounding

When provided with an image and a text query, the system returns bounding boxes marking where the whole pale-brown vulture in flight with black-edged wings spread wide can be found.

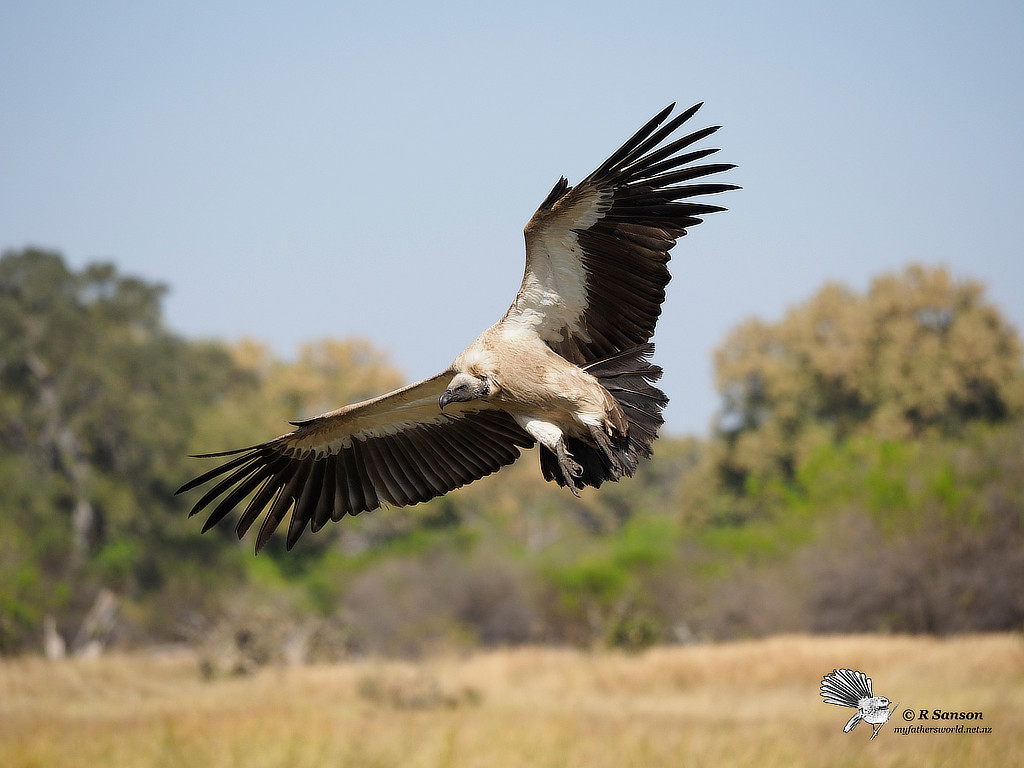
[177,104,738,552]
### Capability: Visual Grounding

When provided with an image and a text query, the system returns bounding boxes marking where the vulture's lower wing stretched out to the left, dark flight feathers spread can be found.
[177,371,534,552]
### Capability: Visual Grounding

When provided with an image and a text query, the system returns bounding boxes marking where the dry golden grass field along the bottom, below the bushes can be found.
[0,635,1024,768]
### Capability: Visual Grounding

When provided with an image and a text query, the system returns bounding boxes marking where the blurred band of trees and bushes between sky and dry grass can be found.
[0,249,1024,673]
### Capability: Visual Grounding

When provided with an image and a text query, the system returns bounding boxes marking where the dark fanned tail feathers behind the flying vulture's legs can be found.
[541,343,669,487]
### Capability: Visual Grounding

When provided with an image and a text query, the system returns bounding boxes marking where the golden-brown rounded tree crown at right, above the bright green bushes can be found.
[715,266,1024,487]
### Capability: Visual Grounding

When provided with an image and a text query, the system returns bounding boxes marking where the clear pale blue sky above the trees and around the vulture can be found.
[0,0,1024,433]
